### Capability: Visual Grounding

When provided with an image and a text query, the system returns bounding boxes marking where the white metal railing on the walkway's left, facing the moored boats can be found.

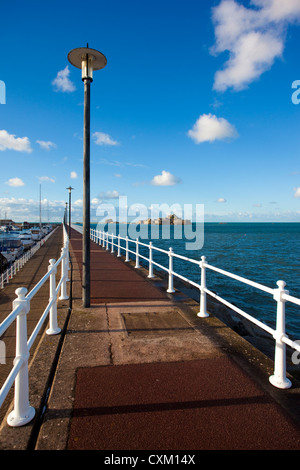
[0,226,69,427]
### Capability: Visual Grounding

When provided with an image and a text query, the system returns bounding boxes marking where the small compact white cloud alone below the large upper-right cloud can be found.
[188,114,238,144]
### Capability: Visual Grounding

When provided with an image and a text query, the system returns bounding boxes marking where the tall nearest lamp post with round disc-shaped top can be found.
[68,44,107,308]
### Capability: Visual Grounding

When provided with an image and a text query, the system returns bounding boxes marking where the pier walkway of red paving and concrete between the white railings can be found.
[0,229,300,451]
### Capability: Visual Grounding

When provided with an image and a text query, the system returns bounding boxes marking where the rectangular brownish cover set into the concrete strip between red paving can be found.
[121,310,195,336]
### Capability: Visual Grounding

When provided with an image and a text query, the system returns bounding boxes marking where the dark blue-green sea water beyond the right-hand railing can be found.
[92,223,300,339]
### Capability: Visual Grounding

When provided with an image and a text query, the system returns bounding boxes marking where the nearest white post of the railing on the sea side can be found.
[269,281,292,389]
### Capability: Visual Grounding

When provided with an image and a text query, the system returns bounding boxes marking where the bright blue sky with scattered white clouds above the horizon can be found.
[0,0,300,222]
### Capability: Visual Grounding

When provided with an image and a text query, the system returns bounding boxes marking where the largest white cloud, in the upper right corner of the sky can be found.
[212,0,300,91]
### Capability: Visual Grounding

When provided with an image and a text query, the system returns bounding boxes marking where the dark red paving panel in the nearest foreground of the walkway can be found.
[68,357,300,450]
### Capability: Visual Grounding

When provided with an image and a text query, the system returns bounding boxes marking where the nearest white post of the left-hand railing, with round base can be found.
[7,287,35,427]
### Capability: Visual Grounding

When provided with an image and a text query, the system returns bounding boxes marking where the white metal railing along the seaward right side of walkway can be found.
[90,229,300,389]
